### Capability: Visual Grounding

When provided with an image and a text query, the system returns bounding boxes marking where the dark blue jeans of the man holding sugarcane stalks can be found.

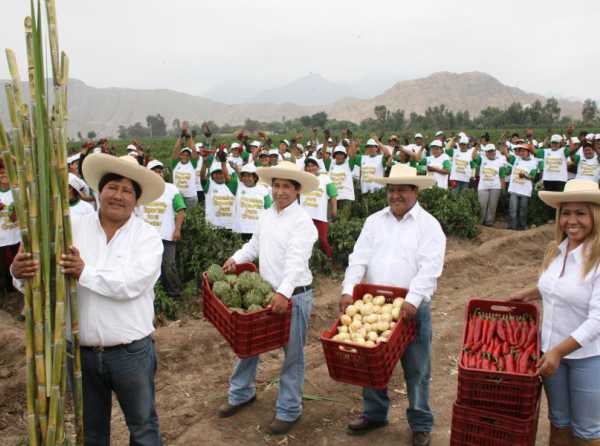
[81,336,162,446]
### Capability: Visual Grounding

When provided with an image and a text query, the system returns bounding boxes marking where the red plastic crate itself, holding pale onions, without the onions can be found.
[321,284,416,389]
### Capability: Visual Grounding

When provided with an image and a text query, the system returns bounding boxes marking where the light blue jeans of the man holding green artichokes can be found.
[229,290,313,421]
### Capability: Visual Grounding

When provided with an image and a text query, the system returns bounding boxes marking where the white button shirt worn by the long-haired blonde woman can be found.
[538,239,600,359]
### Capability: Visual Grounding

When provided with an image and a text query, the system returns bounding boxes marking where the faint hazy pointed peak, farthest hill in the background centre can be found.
[251,73,353,106]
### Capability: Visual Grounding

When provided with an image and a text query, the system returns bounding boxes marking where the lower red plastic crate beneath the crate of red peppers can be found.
[450,403,540,446]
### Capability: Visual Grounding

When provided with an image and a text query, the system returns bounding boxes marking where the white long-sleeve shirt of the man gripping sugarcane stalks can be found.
[15,212,163,347]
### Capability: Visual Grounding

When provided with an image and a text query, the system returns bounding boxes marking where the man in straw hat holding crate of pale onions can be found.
[340,164,446,446]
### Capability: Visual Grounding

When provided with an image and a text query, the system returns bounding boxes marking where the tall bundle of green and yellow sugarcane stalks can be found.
[0,0,83,446]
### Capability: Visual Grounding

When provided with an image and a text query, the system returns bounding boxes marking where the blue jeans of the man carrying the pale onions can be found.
[363,302,433,432]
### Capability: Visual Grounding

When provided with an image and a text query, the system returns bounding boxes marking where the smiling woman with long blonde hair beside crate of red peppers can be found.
[509,179,600,446]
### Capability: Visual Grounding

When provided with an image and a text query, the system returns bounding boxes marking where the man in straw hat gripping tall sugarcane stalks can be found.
[11,153,165,446]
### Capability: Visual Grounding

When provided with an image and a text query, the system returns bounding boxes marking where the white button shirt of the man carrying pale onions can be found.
[342,203,446,308]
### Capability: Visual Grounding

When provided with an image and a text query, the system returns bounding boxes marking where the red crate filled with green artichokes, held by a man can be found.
[202,263,292,358]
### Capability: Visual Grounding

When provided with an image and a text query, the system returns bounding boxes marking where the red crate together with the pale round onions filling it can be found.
[321,284,416,388]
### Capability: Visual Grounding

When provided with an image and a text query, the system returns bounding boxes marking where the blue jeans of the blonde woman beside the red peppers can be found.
[544,356,600,440]
